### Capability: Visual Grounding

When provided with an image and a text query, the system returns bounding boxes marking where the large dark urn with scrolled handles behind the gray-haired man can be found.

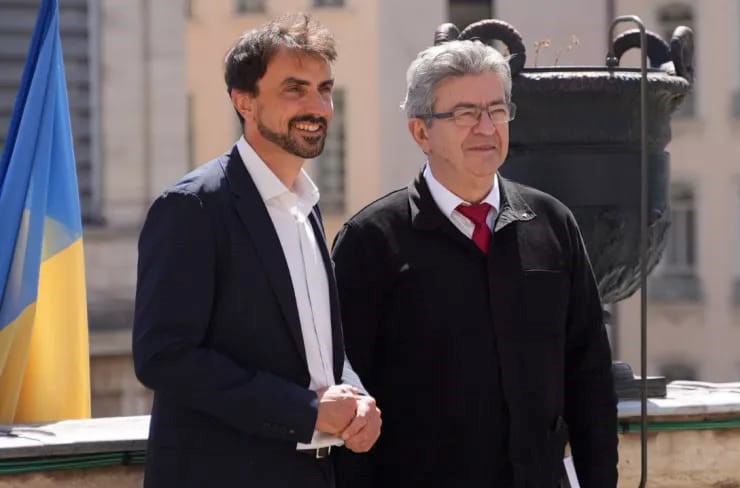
[435,19,693,303]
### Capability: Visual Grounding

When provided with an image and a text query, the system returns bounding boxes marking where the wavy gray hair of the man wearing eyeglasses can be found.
[401,40,511,119]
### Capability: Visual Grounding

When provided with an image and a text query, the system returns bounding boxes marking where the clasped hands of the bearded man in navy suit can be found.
[316,385,382,452]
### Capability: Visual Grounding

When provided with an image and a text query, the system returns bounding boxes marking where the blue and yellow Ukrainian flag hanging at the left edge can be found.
[0,0,90,424]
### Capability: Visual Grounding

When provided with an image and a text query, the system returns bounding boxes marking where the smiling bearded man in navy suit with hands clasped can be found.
[133,15,380,488]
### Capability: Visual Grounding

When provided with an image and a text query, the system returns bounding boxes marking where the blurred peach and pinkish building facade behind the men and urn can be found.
[187,0,740,381]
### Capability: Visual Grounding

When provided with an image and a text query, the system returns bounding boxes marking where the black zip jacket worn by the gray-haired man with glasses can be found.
[333,175,617,488]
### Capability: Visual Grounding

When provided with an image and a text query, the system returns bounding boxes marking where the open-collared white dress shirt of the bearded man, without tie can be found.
[236,137,356,449]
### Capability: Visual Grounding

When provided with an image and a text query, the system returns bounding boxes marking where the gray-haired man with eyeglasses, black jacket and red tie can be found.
[333,41,617,488]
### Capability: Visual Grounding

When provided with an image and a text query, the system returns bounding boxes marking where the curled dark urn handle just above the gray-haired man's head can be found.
[434,19,527,76]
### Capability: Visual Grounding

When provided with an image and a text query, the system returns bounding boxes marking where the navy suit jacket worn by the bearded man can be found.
[133,148,352,488]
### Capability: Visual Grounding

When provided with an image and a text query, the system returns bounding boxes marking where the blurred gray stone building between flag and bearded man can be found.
[0,0,188,417]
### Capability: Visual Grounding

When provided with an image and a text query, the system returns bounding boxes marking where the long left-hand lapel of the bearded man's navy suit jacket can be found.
[224,146,308,364]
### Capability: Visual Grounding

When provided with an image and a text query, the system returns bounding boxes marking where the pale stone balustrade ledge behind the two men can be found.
[0,381,740,488]
